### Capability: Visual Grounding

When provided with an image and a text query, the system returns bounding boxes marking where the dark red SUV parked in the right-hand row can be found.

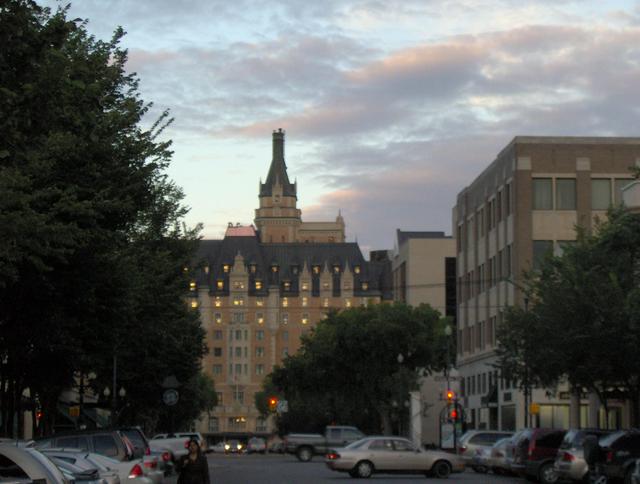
[511,429,567,484]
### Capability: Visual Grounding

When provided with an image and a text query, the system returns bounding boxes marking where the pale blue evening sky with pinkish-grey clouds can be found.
[37,0,640,254]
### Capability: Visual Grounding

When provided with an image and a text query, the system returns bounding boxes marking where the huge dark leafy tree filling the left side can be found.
[0,0,206,435]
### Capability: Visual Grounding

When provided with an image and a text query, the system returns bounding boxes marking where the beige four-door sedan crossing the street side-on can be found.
[325,436,465,478]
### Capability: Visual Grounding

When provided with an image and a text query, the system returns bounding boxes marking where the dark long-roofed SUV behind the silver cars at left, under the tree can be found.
[33,430,135,461]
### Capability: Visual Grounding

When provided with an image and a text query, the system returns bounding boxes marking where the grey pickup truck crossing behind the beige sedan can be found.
[284,426,364,462]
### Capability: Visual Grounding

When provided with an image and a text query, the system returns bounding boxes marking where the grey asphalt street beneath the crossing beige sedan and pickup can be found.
[201,454,526,484]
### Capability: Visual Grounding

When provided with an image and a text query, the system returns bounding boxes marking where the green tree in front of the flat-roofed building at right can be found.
[497,208,640,426]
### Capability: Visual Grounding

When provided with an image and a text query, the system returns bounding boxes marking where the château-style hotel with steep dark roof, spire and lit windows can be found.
[190,130,392,441]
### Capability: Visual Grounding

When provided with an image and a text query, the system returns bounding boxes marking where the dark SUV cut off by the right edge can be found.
[598,430,640,483]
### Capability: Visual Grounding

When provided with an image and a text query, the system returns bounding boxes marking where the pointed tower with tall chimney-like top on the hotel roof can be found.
[254,129,302,243]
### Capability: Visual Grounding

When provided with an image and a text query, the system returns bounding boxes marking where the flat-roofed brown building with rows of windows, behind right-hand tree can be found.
[453,136,640,430]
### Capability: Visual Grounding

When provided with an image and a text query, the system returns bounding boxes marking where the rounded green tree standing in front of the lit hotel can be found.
[263,304,455,433]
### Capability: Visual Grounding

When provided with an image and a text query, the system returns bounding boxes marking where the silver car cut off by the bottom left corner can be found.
[0,444,68,484]
